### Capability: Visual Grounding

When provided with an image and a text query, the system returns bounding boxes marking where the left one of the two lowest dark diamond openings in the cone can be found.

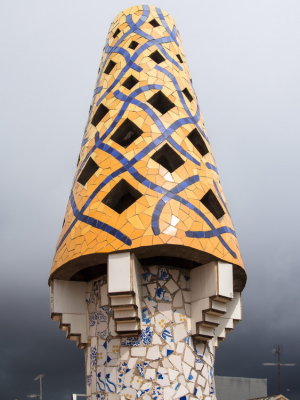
[102,179,142,214]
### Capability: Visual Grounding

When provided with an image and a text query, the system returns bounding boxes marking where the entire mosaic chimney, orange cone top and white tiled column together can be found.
[49,6,246,400]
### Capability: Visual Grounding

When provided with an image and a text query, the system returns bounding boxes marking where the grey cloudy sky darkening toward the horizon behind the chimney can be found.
[0,0,300,400]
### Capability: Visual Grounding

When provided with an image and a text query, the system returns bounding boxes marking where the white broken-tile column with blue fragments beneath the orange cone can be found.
[86,266,216,400]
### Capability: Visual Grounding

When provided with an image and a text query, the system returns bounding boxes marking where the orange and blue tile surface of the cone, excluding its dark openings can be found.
[54,6,242,276]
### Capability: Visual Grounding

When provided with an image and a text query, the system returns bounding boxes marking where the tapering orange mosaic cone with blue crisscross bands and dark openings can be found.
[51,6,245,290]
